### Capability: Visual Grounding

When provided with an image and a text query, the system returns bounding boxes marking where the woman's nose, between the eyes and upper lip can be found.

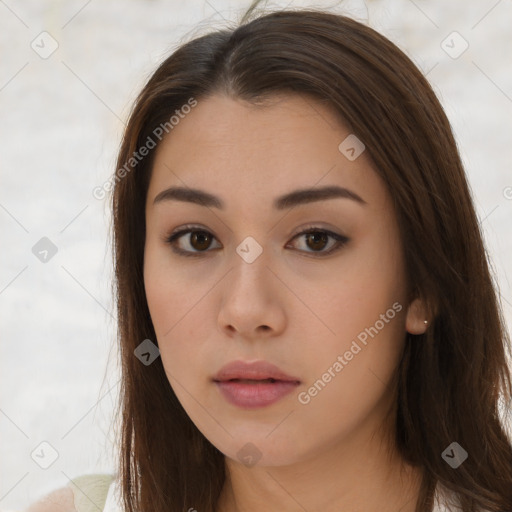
[218,247,289,339]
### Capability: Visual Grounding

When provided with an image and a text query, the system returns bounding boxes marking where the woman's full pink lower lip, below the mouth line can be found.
[215,380,299,409]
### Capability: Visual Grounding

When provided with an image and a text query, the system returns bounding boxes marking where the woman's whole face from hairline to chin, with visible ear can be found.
[144,95,425,466]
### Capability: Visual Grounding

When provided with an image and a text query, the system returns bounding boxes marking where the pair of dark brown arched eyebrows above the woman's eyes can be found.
[153,185,367,210]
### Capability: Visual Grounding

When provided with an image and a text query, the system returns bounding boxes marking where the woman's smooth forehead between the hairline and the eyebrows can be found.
[148,95,386,214]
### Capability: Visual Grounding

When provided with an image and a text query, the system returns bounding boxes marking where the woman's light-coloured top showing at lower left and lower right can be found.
[64,474,472,512]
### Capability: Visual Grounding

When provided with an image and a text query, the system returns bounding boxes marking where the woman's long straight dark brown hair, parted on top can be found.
[112,6,512,512]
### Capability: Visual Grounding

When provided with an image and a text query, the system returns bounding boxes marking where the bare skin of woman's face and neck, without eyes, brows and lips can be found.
[144,95,427,512]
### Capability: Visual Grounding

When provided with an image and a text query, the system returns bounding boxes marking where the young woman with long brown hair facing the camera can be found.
[27,2,512,512]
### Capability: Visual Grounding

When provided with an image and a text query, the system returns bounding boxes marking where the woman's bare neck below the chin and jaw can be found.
[218,422,421,512]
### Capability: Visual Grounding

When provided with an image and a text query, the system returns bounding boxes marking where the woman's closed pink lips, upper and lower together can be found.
[213,361,300,409]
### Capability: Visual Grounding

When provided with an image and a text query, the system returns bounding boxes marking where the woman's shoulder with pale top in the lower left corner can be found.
[25,474,115,512]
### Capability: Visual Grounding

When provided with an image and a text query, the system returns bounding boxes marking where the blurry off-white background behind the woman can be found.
[0,0,512,511]
